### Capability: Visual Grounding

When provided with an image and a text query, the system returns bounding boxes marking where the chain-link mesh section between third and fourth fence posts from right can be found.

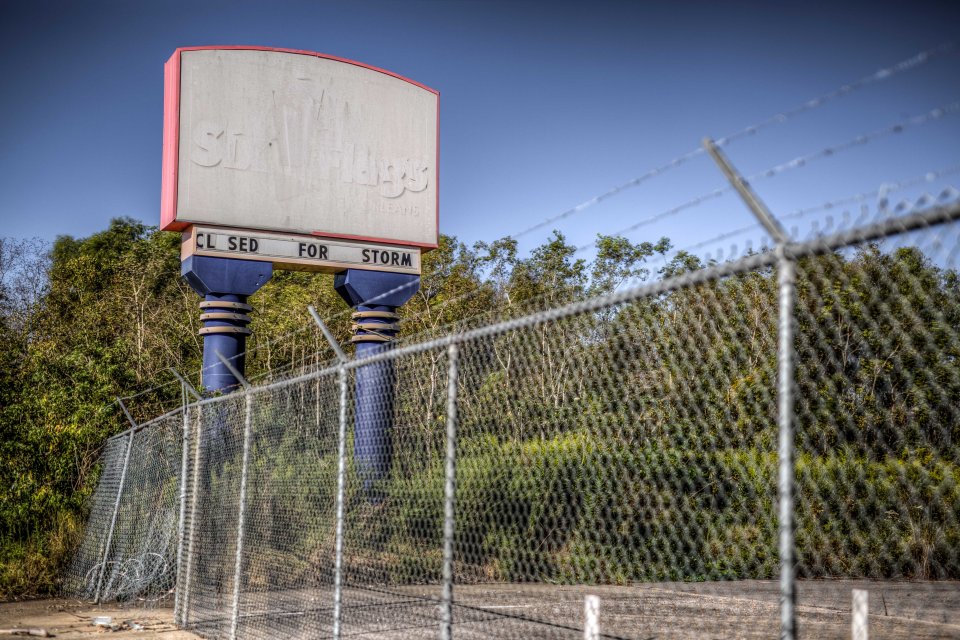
[233,376,339,637]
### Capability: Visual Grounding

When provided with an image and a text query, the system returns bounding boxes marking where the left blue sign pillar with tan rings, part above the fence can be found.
[180,256,273,393]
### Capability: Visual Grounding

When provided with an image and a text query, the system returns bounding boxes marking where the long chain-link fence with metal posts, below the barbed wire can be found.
[66,201,960,639]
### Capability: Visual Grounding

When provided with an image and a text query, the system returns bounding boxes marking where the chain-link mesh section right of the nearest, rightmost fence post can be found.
[796,224,960,637]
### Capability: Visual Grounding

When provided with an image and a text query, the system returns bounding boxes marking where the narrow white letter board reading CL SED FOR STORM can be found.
[180,226,420,275]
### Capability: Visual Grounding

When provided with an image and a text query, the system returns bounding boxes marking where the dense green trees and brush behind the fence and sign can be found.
[0,220,960,597]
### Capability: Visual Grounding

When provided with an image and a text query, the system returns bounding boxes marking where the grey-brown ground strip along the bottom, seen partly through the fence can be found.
[0,580,960,640]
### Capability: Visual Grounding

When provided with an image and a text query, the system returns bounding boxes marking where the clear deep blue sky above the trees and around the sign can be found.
[0,0,960,264]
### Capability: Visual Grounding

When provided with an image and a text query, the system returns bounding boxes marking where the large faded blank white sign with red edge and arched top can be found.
[161,49,439,249]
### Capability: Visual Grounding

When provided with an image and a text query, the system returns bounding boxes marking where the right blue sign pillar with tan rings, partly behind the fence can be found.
[334,269,420,501]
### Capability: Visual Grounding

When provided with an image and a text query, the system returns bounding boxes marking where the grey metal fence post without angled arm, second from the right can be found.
[440,343,460,640]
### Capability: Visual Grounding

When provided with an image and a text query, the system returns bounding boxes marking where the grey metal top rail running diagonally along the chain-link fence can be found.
[124,202,960,416]
